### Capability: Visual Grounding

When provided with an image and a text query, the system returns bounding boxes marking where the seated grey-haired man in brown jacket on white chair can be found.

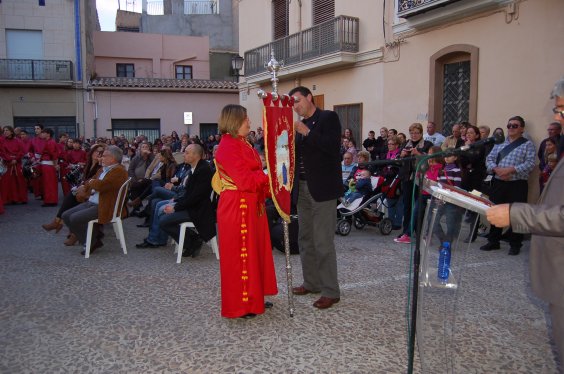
[62,145,127,255]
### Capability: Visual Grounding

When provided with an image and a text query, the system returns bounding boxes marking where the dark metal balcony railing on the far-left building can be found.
[0,59,72,81]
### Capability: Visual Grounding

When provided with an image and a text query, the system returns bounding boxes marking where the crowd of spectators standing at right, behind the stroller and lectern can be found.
[341,116,564,255]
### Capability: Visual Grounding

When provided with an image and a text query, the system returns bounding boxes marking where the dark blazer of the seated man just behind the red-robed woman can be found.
[174,160,216,241]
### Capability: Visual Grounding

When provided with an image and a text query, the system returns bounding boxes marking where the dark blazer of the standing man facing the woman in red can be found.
[294,108,344,202]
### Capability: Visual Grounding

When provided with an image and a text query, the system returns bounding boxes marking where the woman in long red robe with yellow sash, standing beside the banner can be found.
[214,104,278,318]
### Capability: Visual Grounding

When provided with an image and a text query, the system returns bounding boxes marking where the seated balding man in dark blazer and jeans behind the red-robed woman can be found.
[136,144,216,257]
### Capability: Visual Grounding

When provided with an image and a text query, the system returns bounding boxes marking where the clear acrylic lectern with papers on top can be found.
[417,184,492,374]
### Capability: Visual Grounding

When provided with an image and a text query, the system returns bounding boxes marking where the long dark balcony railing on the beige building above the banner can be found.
[245,16,359,76]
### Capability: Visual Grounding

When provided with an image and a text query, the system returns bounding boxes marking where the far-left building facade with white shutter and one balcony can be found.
[0,0,96,136]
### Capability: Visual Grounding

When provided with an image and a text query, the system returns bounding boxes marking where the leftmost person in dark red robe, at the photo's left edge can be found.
[0,126,27,204]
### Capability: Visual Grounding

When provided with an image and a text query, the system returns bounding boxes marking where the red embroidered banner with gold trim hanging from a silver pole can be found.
[263,93,295,223]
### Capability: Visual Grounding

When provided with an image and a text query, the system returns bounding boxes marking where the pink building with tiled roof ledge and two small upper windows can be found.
[84,31,239,140]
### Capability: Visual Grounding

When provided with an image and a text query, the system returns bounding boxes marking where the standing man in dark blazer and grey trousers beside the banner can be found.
[290,87,343,309]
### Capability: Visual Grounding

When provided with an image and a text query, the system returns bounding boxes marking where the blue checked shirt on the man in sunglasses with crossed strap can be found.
[486,138,535,181]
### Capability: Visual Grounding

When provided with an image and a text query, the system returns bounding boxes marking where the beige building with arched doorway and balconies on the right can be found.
[239,0,564,197]
